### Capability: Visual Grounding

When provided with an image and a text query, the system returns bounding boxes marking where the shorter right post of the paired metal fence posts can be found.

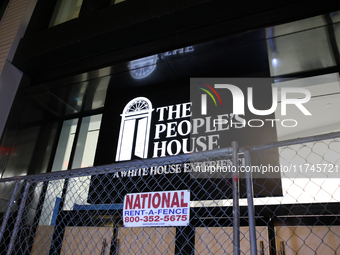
[244,150,257,255]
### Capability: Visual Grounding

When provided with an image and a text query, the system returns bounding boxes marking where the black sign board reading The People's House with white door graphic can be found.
[88,78,284,204]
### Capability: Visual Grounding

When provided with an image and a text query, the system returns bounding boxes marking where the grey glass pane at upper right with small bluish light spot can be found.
[267,27,335,76]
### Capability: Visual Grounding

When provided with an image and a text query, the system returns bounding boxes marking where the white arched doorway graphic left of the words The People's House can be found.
[116,97,153,161]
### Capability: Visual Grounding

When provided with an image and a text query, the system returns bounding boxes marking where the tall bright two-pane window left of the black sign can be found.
[39,114,102,225]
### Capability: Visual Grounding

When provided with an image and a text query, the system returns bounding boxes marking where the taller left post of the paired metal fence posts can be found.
[231,141,241,255]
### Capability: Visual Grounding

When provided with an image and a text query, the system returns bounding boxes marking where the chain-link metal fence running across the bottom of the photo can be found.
[0,133,340,255]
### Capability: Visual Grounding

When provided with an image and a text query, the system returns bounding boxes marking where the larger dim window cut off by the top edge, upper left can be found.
[50,0,83,27]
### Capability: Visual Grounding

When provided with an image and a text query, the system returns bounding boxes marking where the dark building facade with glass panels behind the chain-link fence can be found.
[0,0,340,254]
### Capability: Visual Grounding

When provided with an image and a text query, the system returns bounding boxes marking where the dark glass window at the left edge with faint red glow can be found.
[0,97,59,178]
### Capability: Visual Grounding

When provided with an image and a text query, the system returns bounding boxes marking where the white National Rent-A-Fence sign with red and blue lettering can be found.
[123,190,190,227]
